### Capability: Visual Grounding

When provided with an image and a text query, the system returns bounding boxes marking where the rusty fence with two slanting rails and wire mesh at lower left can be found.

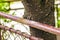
[0,0,60,40]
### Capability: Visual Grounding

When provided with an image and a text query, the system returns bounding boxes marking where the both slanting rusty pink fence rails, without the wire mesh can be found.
[0,12,60,40]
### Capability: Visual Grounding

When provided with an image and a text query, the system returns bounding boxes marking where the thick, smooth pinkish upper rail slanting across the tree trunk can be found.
[0,12,60,35]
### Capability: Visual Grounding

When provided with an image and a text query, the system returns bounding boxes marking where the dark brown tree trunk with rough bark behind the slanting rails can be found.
[22,0,56,40]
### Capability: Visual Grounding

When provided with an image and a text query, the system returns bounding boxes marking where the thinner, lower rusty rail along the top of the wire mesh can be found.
[0,25,43,40]
